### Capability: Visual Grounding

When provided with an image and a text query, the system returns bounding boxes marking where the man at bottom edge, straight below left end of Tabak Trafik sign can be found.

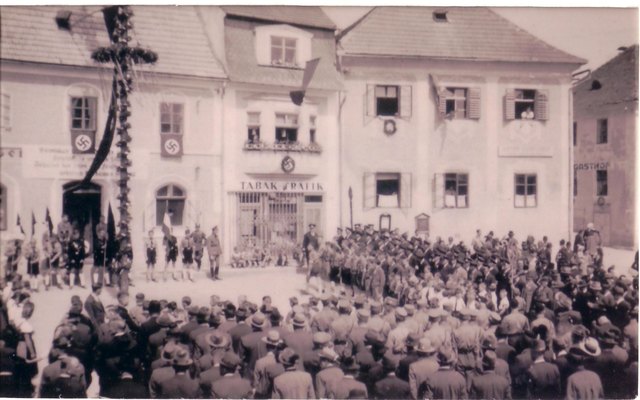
[210,351,253,399]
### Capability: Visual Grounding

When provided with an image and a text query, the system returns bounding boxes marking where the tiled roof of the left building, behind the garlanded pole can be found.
[0,6,225,78]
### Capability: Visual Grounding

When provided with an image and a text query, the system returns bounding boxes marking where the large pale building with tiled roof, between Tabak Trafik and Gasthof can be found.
[339,7,583,245]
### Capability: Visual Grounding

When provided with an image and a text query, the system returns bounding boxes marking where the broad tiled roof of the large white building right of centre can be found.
[340,7,586,64]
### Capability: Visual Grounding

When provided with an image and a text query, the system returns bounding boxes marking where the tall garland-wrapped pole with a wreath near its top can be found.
[91,5,158,253]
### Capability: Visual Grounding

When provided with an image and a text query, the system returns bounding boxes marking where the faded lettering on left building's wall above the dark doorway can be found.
[22,145,149,180]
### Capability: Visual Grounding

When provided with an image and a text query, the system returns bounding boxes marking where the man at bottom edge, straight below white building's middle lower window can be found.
[425,347,467,399]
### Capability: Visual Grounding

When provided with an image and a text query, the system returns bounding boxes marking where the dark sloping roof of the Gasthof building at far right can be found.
[573,44,638,112]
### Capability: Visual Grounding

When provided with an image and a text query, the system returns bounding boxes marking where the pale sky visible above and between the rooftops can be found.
[323,6,638,70]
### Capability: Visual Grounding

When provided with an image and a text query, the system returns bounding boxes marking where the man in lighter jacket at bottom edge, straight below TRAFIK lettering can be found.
[271,348,315,399]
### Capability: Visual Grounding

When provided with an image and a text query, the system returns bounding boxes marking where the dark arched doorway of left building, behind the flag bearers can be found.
[62,181,102,251]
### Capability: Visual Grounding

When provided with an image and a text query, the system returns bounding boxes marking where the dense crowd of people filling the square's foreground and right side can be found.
[0,220,638,399]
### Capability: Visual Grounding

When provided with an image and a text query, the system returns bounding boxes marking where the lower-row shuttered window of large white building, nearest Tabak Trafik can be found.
[363,173,411,209]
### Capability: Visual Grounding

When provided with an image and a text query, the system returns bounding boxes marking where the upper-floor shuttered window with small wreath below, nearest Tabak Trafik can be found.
[366,85,412,118]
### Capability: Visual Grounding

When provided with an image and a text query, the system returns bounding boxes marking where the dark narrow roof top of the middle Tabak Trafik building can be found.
[222,6,336,30]
